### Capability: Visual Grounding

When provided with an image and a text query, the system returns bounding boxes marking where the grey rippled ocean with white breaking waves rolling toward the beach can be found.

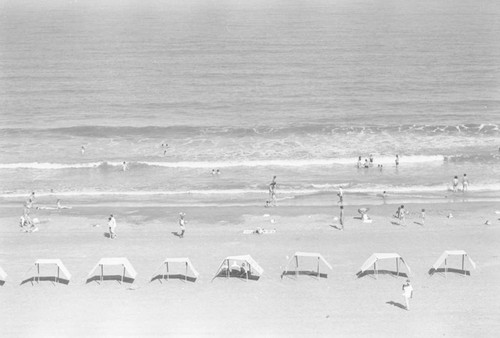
[0,0,500,206]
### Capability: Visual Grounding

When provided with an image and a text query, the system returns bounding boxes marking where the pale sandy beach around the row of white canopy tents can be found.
[0,203,500,337]
